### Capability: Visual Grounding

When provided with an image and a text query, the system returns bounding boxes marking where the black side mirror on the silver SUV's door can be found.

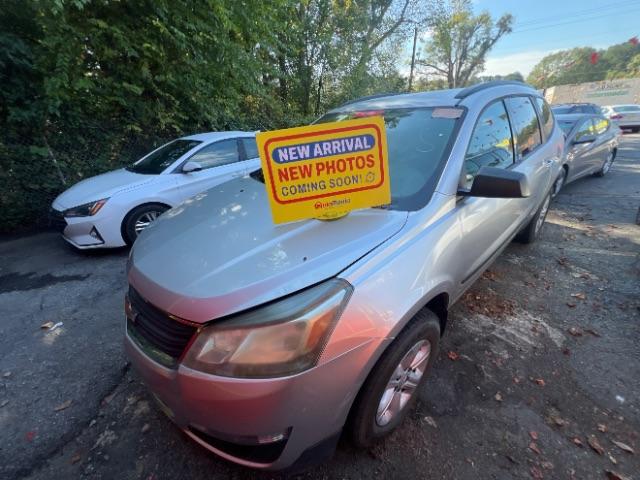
[458,167,531,198]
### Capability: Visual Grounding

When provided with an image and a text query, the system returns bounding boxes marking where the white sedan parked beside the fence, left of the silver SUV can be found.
[51,132,260,249]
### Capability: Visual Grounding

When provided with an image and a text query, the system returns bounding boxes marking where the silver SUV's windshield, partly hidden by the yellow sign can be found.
[316,107,463,210]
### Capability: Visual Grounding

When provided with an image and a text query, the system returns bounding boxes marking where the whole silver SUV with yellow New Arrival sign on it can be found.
[125,82,564,470]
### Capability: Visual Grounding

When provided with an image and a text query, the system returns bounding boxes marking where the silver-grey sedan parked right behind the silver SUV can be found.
[554,114,621,196]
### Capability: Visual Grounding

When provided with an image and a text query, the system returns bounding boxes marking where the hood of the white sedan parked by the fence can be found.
[53,168,157,210]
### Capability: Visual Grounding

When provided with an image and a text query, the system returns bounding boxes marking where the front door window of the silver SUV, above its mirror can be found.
[464,100,513,188]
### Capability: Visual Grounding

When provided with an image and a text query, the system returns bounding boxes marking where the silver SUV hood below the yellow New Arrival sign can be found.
[129,177,408,323]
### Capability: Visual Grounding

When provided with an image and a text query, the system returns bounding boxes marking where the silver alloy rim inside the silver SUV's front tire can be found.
[376,340,431,427]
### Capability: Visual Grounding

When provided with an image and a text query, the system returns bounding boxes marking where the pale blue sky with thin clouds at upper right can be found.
[409,0,640,78]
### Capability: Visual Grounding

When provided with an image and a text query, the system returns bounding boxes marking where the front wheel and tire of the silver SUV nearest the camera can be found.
[348,309,440,448]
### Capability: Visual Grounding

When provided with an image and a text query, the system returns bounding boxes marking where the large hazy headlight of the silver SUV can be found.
[184,279,353,378]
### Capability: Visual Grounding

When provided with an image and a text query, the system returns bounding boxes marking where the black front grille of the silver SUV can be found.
[128,287,197,360]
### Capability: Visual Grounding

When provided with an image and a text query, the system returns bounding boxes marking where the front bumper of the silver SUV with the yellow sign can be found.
[125,326,380,470]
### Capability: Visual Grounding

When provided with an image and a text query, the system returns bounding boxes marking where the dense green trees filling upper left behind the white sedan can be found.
[0,0,421,231]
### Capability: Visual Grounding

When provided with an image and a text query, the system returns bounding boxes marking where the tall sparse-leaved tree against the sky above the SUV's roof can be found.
[417,0,513,88]
